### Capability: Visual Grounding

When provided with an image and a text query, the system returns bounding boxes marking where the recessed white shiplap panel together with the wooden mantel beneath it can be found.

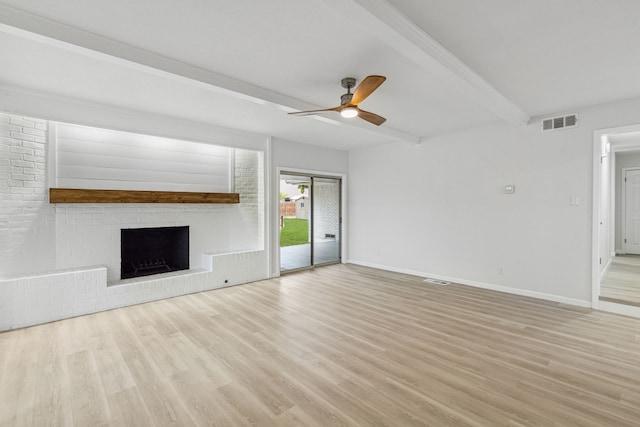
[49,123,241,203]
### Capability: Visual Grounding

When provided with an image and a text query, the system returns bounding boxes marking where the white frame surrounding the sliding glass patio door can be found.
[269,166,348,277]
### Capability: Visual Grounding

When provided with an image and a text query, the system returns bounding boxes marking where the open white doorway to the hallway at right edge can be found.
[592,125,640,317]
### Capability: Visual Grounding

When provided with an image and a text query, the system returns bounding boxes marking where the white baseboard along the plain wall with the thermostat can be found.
[347,260,591,308]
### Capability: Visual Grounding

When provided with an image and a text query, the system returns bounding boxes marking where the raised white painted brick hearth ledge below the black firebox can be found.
[0,250,266,331]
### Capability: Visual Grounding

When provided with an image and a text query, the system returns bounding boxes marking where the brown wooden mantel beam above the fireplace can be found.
[49,188,240,203]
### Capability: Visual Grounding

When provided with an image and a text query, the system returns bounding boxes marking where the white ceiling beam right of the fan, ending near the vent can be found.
[323,0,529,125]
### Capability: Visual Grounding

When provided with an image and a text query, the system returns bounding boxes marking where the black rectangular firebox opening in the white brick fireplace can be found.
[120,226,189,279]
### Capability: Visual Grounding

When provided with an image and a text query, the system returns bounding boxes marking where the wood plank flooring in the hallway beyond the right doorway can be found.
[600,255,640,306]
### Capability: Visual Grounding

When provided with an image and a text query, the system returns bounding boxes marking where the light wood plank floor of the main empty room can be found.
[0,265,640,426]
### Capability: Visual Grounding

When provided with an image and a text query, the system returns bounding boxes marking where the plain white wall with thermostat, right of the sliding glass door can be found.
[348,99,640,305]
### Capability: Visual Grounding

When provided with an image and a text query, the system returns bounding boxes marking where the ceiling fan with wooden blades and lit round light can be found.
[289,76,387,126]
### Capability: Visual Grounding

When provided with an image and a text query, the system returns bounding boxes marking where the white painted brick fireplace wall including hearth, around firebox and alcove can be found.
[0,113,268,330]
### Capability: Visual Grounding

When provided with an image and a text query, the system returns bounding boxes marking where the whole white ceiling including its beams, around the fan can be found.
[0,0,640,149]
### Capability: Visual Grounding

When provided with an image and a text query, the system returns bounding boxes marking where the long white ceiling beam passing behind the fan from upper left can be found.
[0,5,420,144]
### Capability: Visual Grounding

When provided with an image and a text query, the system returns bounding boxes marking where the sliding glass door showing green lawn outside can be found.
[279,171,342,273]
